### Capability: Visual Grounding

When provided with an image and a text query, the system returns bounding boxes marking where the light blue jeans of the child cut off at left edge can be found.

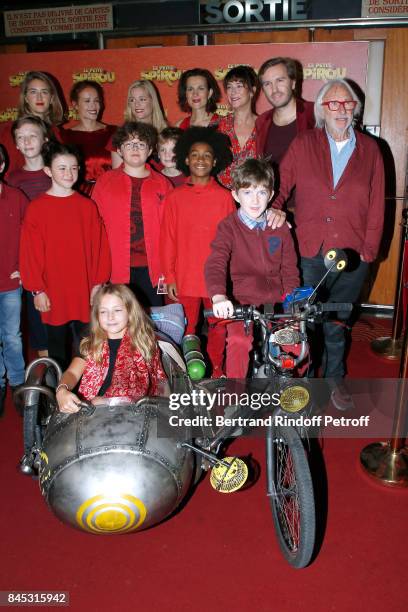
[0,288,24,387]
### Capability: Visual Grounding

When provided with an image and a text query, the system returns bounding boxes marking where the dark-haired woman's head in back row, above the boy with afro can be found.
[176,68,221,130]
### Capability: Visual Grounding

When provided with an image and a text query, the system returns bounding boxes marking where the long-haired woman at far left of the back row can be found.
[0,71,64,175]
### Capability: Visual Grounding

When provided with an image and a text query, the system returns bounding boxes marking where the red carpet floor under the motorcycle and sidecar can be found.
[0,319,407,612]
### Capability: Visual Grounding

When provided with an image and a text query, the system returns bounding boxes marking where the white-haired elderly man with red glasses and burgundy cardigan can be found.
[273,79,384,410]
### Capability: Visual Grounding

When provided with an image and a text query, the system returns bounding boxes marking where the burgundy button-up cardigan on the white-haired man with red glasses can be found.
[273,128,384,261]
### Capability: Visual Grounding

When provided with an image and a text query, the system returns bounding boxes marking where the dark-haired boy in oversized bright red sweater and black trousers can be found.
[20,142,111,368]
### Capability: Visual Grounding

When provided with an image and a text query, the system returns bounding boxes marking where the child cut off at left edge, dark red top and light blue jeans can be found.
[0,145,28,416]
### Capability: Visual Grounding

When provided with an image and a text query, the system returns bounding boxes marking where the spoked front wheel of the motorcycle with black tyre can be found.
[266,426,316,568]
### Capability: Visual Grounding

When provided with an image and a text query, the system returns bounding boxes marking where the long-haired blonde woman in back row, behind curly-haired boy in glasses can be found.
[107,79,167,168]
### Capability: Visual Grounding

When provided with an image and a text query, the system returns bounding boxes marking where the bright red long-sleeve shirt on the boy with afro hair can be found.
[160,179,235,297]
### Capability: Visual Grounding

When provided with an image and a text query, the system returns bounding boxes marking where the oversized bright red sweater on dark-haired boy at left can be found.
[20,193,111,325]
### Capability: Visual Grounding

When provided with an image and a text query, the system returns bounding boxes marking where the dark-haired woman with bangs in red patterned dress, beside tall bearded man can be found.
[218,66,259,189]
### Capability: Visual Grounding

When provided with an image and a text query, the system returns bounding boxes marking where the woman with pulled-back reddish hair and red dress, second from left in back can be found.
[60,81,116,196]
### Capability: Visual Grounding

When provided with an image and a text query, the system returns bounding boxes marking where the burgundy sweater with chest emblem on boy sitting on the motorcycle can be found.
[205,212,299,306]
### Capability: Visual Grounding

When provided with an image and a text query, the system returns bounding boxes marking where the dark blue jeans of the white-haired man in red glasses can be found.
[300,254,368,379]
